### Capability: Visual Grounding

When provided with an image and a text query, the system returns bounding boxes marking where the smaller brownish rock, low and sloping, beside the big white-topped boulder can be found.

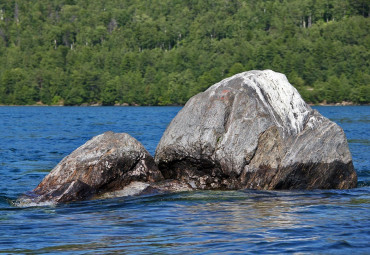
[31,132,163,203]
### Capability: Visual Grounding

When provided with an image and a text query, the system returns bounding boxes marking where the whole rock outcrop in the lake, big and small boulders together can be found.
[18,70,357,206]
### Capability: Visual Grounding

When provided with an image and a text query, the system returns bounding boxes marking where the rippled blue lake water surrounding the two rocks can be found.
[0,106,370,254]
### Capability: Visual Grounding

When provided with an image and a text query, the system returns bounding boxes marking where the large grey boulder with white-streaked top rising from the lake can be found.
[155,70,357,189]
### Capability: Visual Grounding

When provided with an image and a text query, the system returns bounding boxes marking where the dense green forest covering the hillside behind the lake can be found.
[0,0,370,105]
